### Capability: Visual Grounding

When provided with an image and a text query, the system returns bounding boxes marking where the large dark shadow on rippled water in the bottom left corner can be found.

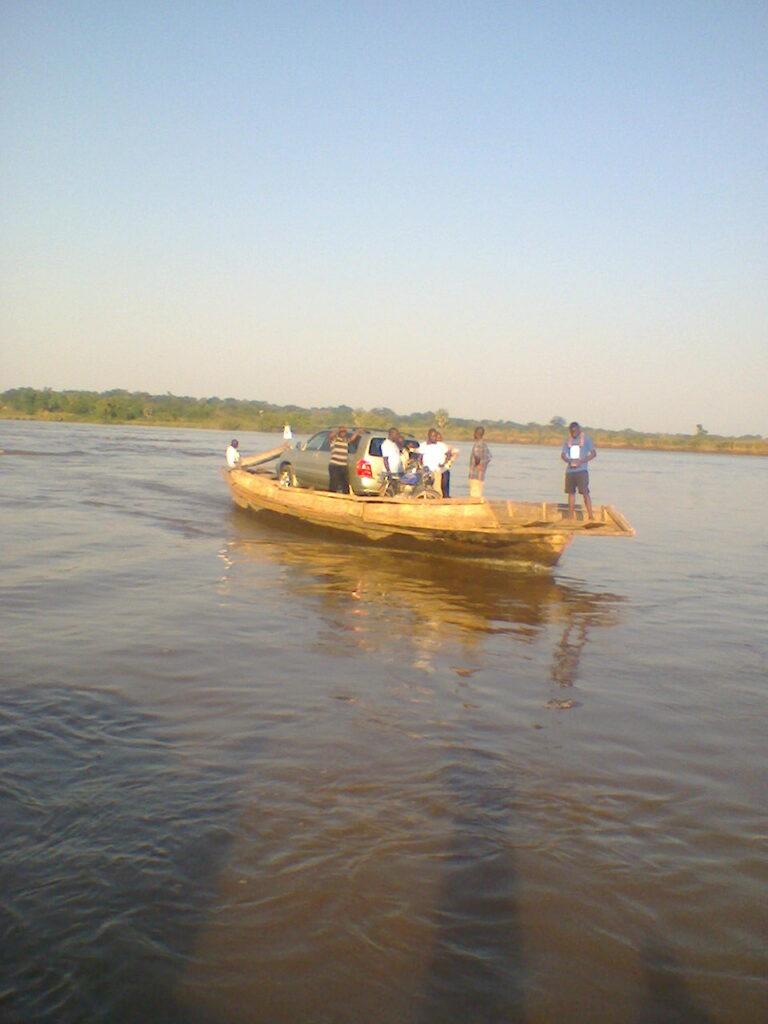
[0,687,244,1024]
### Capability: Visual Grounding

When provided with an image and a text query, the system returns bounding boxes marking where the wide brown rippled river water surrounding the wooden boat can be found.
[0,422,768,1024]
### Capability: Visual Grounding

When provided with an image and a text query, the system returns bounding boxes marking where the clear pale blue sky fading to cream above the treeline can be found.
[0,0,768,434]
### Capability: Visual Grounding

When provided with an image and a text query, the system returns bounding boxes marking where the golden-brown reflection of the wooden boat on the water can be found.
[221,513,624,687]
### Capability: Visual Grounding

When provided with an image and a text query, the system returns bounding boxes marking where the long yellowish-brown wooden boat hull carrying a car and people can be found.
[224,449,635,565]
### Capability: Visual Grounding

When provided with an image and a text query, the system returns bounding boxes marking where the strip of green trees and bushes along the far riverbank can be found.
[0,387,768,455]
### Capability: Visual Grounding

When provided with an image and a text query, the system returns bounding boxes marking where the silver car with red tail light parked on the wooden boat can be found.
[276,429,416,495]
